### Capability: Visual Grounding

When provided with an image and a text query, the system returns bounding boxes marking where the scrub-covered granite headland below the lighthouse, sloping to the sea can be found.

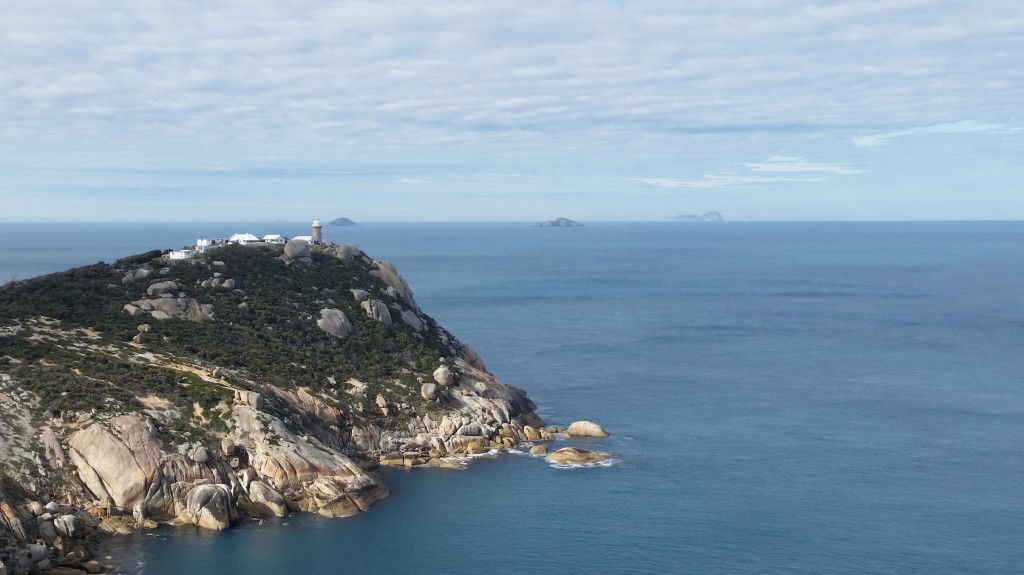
[0,240,554,575]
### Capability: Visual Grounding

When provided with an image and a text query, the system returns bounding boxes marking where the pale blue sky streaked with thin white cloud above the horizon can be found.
[0,0,1024,222]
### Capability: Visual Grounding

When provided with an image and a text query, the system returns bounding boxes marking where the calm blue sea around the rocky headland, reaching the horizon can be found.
[0,222,1024,575]
